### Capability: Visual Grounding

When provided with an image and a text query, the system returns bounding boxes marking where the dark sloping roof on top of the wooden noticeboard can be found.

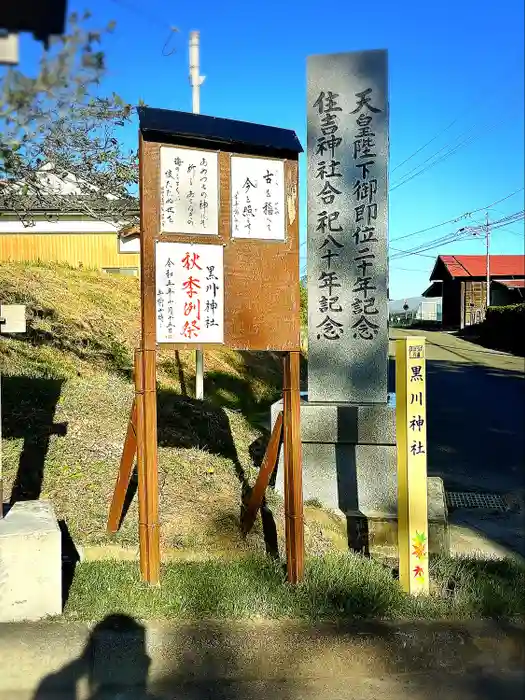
[137,107,303,158]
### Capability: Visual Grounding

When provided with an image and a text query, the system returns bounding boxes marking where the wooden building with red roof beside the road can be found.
[423,255,525,328]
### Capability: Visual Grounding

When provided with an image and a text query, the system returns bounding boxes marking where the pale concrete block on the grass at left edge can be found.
[0,501,62,622]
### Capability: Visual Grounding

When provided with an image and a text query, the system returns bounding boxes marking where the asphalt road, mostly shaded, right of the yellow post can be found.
[391,329,525,495]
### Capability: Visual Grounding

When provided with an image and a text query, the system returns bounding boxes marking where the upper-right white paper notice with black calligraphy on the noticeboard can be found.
[231,156,285,241]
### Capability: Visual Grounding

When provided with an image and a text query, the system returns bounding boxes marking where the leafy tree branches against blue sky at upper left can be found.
[0,13,138,225]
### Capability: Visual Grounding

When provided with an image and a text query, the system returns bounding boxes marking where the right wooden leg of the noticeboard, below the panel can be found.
[283,351,304,583]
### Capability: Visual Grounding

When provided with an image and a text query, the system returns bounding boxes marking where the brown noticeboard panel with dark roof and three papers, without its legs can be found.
[138,107,302,351]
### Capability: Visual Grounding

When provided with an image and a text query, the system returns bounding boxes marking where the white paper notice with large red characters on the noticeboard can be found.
[155,241,224,344]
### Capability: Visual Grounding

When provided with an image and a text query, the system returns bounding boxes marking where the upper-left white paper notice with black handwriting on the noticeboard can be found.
[160,146,219,235]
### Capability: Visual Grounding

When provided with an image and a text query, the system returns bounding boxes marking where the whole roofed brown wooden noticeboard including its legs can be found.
[108,107,304,582]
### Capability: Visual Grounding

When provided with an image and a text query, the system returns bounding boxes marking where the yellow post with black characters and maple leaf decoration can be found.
[396,336,429,595]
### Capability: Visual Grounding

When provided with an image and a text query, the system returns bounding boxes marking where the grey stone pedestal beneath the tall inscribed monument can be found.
[271,397,449,556]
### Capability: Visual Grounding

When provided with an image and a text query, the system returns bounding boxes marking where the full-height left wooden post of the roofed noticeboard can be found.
[139,134,160,584]
